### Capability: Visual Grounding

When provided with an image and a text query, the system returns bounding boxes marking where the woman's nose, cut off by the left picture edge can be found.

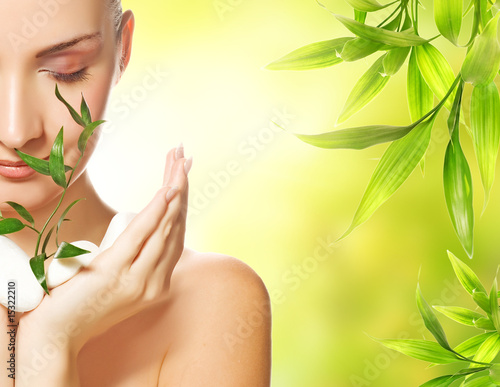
[0,75,43,149]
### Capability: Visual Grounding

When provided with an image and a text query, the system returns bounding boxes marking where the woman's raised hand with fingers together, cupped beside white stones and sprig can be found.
[15,145,188,378]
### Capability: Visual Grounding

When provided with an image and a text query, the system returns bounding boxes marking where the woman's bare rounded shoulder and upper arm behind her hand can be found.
[160,249,271,387]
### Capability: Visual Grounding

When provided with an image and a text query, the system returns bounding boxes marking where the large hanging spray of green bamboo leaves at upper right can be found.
[266,0,500,257]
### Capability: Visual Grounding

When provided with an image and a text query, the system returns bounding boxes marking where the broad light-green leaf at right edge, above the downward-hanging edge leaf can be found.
[461,13,500,86]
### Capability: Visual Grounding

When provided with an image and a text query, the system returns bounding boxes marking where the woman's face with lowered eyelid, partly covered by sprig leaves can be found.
[0,0,128,209]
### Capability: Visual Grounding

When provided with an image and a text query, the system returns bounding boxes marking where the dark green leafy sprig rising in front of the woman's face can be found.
[0,84,105,294]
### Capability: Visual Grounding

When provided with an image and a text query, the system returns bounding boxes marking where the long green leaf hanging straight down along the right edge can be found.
[470,82,500,208]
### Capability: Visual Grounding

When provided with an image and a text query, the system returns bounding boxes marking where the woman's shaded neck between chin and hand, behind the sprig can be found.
[4,171,116,257]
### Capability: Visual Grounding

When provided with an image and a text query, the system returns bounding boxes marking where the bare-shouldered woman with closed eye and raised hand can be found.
[0,0,270,387]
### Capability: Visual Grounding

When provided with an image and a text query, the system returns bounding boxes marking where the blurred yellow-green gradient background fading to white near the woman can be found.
[89,0,500,387]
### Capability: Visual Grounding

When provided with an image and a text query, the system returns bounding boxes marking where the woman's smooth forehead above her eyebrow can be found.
[0,0,112,58]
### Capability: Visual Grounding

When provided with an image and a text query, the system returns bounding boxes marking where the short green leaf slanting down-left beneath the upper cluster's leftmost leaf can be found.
[337,54,390,124]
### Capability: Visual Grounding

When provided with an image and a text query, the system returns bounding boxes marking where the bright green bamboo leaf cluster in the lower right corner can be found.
[374,252,500,387]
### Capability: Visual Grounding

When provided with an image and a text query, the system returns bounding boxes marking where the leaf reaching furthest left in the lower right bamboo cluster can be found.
[372,337,463,364]
